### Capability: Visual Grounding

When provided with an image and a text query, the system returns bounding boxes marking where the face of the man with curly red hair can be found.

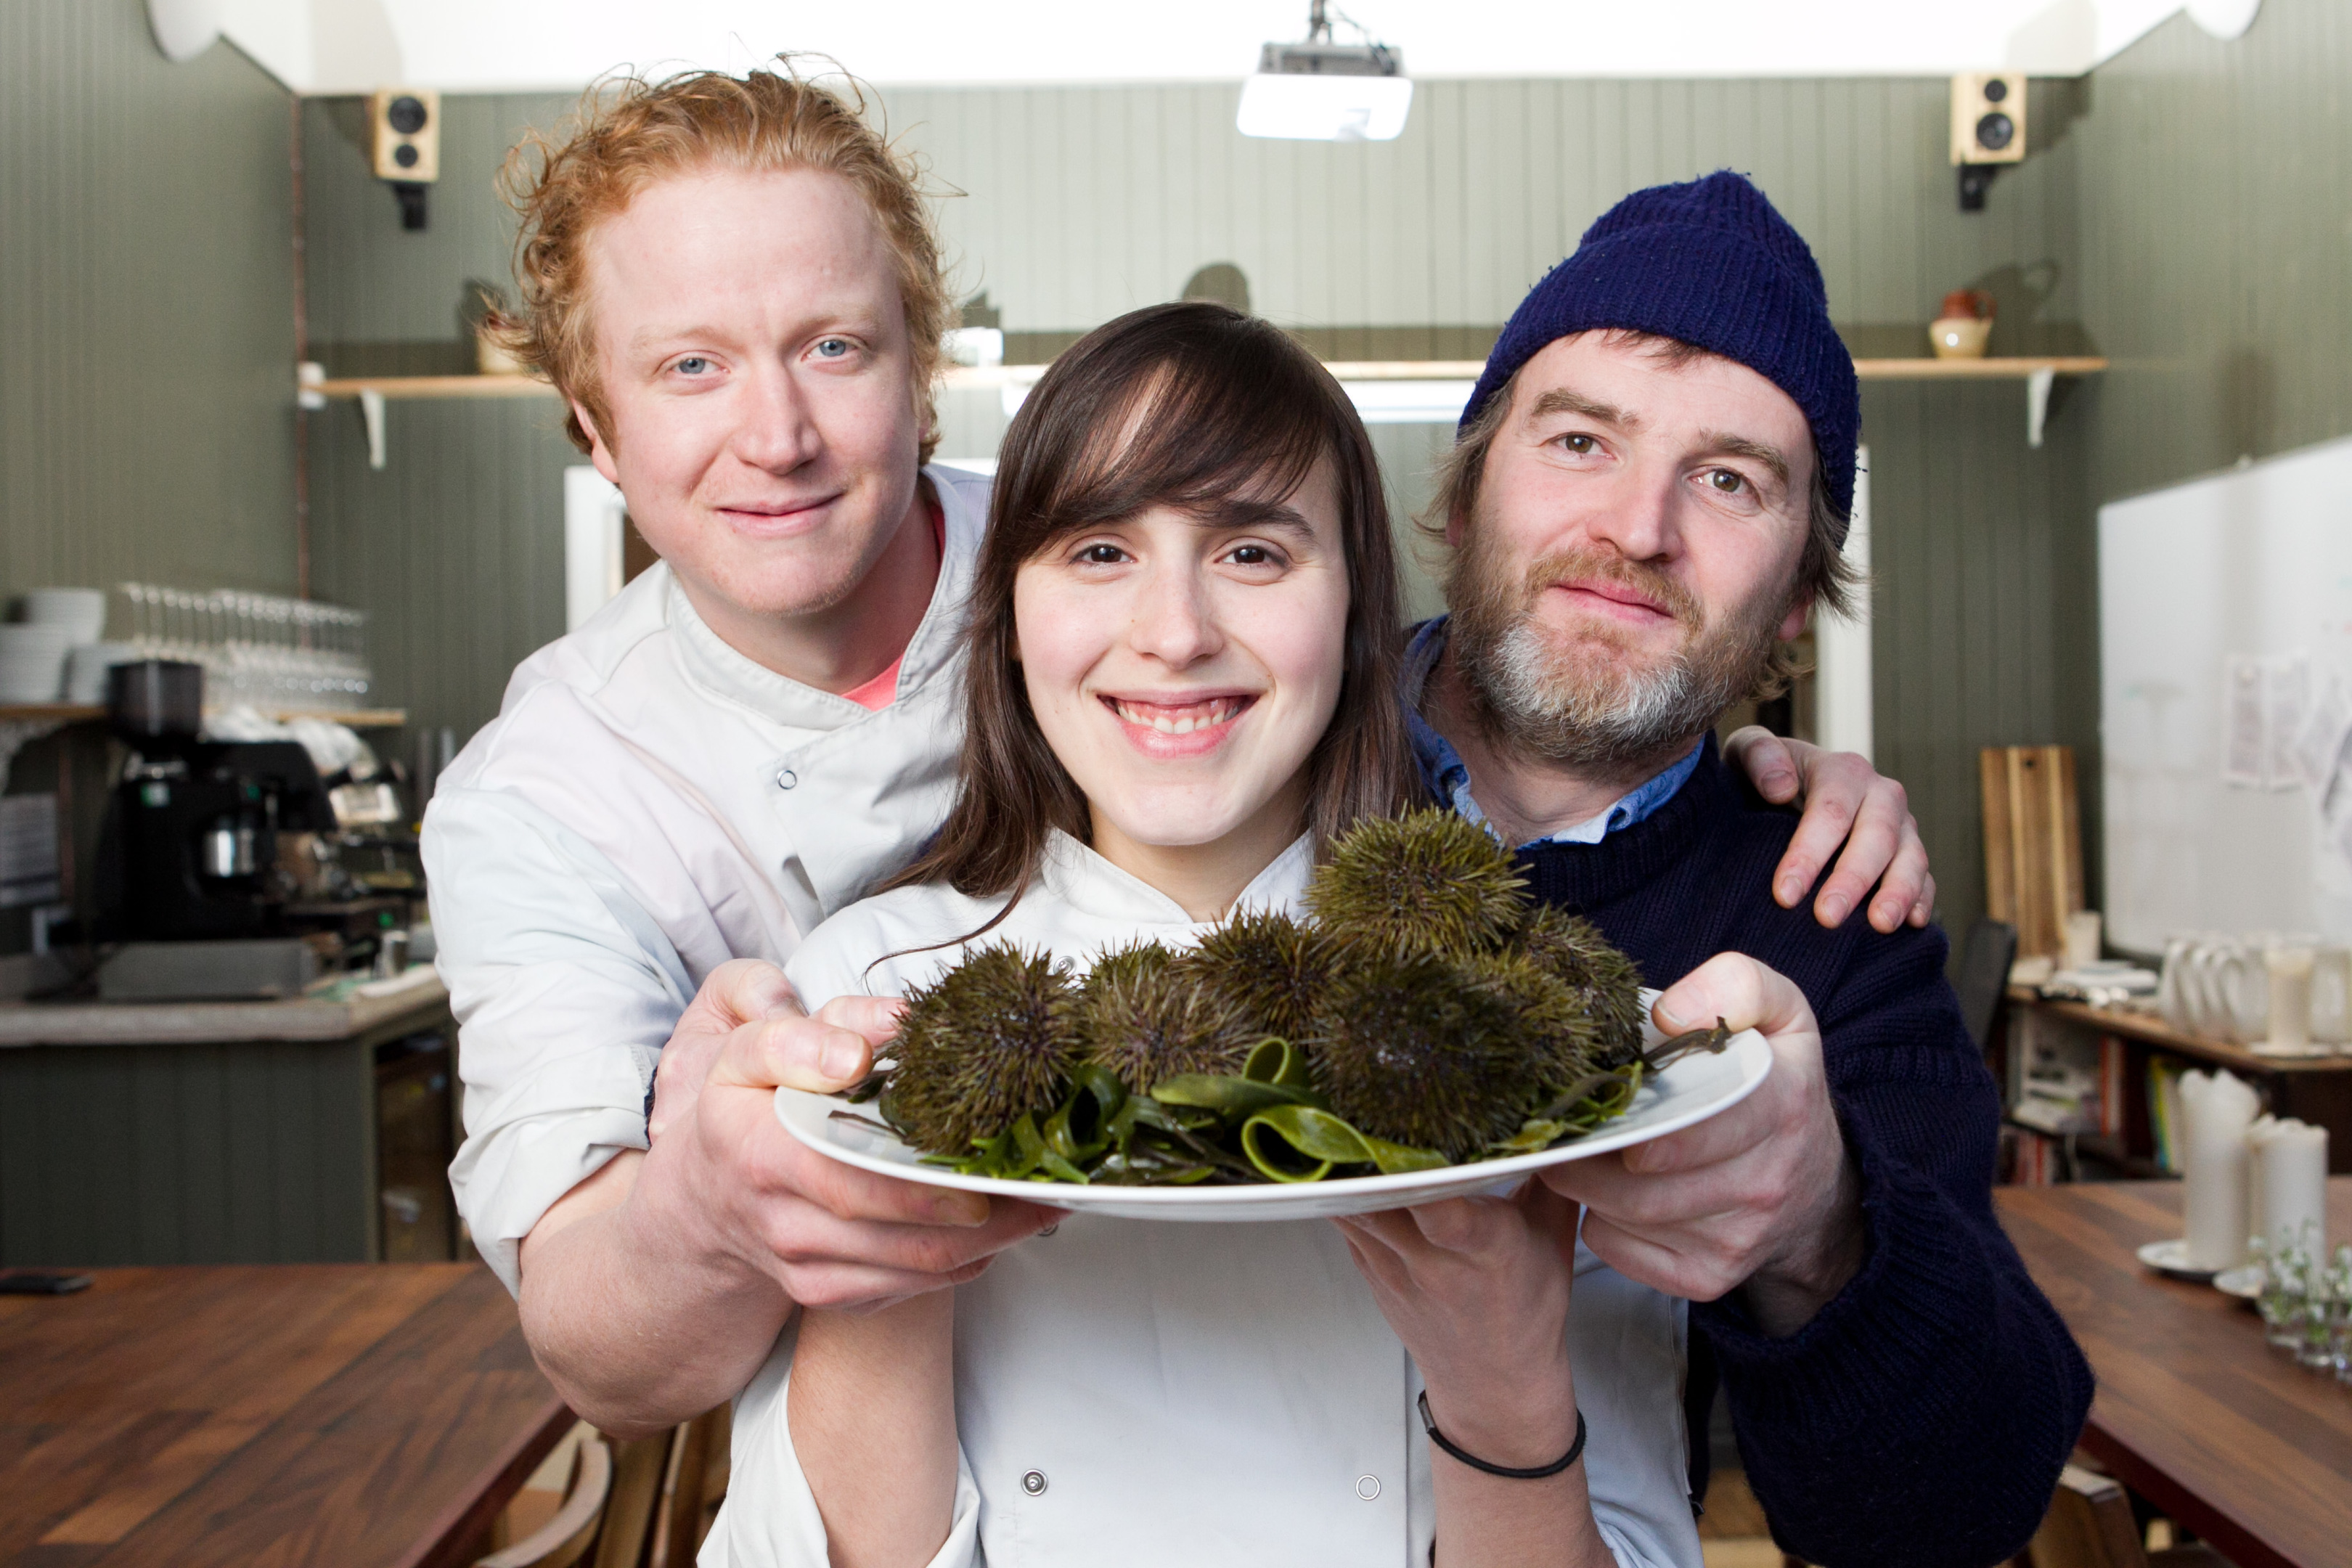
[581,169,922,621]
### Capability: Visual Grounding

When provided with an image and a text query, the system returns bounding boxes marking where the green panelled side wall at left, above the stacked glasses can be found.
[0,0,294,592]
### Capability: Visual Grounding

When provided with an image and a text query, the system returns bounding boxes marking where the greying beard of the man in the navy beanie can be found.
[1453,616,1773,771]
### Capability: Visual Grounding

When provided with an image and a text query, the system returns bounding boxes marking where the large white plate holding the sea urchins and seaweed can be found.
[776,989,1771,1222]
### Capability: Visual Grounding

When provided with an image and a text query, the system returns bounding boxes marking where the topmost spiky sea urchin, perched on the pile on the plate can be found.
[1307,811,1527,957]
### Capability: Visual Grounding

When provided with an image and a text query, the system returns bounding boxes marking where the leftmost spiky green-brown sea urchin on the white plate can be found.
[884,943,1079,1154]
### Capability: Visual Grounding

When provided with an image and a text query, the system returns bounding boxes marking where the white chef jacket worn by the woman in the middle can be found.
[701,835,1701,1568]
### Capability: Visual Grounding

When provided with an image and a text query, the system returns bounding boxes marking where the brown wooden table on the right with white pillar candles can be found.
[1995,1177,2352,1568]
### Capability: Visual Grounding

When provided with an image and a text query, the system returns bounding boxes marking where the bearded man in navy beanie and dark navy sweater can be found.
[1407,171,2091,1568]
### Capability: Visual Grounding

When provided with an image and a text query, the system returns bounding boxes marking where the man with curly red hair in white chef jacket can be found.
[425,70,1931,1434]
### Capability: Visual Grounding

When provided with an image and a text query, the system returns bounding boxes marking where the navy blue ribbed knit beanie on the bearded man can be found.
[1461,169,1863,526]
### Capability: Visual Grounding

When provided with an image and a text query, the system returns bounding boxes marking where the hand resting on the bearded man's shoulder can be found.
[1724,724,1936,931]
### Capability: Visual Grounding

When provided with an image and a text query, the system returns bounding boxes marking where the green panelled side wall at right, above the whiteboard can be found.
[2079,0,2352,503]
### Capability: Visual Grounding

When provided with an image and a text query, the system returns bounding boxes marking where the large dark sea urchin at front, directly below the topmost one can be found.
[1307,950,1548,1161]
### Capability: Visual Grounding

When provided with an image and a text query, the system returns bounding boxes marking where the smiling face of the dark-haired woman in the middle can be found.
[1013,465,1348,846]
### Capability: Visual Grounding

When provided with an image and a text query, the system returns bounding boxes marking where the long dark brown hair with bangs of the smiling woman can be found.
[886,301,1413,907]
